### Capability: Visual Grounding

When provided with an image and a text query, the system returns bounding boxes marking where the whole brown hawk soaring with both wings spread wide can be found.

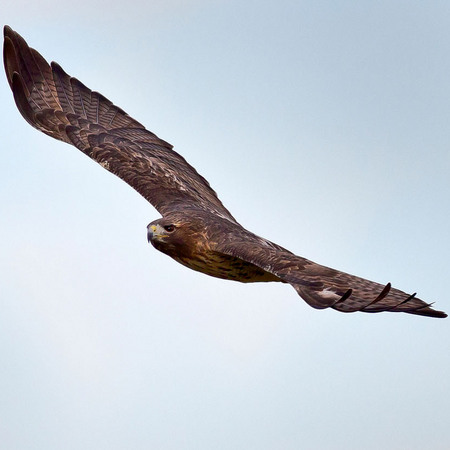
[3,26,447,317]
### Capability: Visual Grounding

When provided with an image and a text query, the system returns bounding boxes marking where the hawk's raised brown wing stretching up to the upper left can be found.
[3,26,235,221]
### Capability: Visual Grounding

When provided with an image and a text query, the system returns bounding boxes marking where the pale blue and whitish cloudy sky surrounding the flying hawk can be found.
[0,0,450,450]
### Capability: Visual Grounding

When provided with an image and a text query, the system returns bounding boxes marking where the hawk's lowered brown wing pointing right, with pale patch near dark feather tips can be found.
[216,233,447,317]
